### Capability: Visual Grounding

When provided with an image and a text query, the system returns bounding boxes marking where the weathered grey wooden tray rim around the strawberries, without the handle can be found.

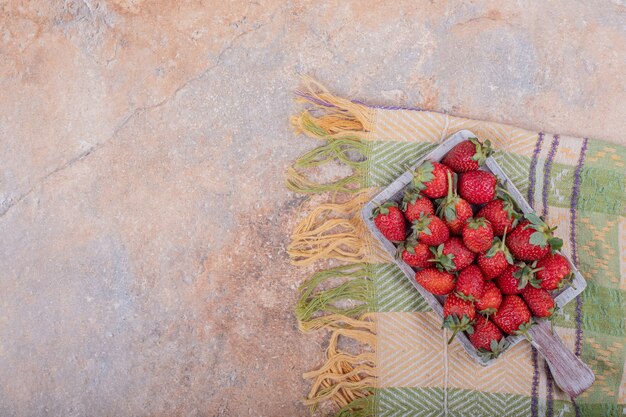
[361,130,587,366]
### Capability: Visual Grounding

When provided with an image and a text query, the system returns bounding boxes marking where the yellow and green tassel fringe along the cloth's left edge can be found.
[287,77,380,417]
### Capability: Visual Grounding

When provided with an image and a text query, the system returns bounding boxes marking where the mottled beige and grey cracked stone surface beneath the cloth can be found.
[0,0,626,416]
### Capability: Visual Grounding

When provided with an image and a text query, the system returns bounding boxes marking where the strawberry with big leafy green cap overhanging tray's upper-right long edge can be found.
[507,213,563,261]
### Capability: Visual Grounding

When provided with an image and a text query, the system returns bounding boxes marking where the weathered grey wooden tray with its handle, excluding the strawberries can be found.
[361,130,594,395]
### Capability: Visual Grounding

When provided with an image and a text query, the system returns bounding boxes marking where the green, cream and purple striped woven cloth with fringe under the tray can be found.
[287,79,626,417]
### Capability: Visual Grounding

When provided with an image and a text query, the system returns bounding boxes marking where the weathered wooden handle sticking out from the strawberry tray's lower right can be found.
[528,320,596,397]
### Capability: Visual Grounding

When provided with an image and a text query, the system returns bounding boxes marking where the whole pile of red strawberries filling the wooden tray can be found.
[373,138,573,359]
